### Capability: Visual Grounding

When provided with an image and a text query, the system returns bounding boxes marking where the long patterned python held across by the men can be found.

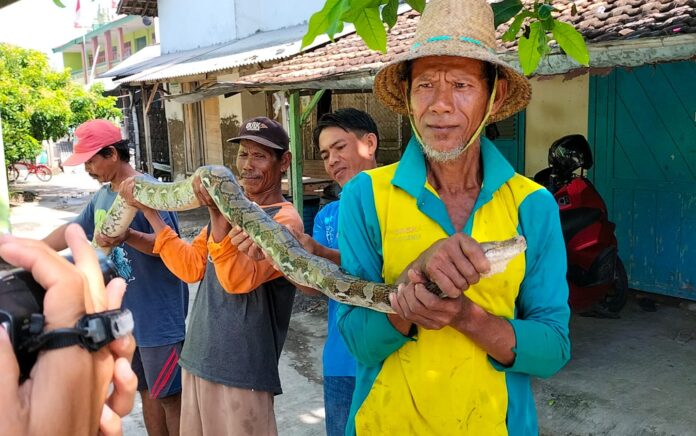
[95,166,526,313]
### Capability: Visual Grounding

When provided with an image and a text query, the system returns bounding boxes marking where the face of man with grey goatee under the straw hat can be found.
[410,56,489,161]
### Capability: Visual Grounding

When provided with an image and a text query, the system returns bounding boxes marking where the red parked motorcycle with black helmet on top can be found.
[534,135,628,317]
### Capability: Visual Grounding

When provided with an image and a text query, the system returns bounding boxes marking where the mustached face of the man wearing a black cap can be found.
[237,139,290,196]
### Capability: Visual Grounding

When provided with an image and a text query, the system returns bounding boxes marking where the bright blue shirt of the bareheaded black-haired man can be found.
[312,201,355,377]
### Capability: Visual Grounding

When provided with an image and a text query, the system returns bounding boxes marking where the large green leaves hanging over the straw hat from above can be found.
[302,0,590,75]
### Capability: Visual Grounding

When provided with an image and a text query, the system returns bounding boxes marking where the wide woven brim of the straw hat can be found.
[373,40,532,123]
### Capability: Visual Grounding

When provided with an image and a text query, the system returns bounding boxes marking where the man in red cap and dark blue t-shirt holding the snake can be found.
[44,120,188,436]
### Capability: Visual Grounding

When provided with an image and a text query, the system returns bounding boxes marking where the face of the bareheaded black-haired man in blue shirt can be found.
[319,127,377,187]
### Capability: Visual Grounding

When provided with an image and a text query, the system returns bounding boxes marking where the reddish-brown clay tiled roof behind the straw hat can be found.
[238,0,696,86]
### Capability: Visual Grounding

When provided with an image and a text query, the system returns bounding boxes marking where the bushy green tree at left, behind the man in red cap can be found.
[0,44,120,162]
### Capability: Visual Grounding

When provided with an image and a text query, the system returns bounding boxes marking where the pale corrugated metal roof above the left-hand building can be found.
[100,24,307,83]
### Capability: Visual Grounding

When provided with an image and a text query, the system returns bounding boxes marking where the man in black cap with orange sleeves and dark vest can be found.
[121,117,303,435]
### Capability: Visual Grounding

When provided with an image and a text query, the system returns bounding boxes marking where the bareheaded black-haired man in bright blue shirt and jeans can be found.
[300,108,379,436]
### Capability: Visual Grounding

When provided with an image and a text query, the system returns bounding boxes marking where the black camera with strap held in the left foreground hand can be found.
[0,253,133,380]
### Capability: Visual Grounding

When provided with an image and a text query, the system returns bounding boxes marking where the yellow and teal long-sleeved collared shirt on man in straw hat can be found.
[338,138,570,435]
